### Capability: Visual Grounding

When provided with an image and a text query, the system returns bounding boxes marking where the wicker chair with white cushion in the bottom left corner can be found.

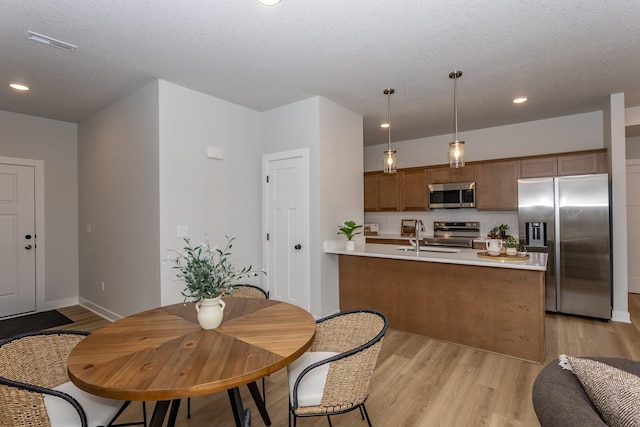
[0,330,146,427]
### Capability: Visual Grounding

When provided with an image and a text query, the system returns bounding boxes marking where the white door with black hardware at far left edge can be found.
[0,164,36,317]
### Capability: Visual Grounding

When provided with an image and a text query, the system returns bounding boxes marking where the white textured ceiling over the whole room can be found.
[0,0,640,145]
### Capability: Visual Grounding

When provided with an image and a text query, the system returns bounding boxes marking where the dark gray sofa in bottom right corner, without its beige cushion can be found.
[533,357,640,427]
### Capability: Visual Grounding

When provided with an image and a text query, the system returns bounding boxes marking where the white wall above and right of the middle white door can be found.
[261,96,363,317]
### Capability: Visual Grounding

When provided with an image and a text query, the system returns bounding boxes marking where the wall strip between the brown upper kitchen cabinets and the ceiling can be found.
[364,111,604,171]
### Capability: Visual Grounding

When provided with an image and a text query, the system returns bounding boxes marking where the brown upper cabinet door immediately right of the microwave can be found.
[476,161,520,211]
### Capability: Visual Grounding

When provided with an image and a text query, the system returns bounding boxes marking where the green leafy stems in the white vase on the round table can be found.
[168,236,264,301]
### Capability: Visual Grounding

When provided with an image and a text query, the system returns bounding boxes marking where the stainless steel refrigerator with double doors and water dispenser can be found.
[518,174,612,319]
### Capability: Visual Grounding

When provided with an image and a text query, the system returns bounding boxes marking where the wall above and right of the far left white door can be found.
[0,111,78,308]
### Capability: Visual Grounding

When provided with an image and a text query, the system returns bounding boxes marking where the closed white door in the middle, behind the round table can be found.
[263,150,310,310]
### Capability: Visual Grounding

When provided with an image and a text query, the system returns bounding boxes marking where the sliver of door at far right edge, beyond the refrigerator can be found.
[627,160,640,294]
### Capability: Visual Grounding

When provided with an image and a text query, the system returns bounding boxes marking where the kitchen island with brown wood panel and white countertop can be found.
[325,242,547,363]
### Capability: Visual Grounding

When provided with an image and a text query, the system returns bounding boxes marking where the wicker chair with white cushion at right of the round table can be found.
[287,310,387,427]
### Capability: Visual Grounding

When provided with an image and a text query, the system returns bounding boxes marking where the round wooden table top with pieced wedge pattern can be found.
[68,298,316,401]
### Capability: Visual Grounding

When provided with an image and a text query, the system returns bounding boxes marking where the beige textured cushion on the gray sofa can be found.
[559,355,640,426]
